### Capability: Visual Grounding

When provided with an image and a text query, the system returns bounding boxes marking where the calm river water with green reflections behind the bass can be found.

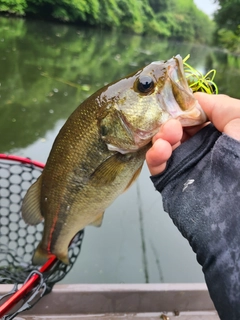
[0,17,240,283]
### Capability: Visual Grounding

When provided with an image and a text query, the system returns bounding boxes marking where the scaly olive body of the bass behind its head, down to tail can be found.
[23,90,148,265]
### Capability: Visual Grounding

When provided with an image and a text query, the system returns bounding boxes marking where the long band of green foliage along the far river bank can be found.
[0,0,212,43]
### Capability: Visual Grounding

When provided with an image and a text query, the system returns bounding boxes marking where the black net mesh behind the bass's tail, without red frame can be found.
[0,159,83,290]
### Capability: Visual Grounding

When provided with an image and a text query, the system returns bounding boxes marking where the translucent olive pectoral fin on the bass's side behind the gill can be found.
[90,154,126,186]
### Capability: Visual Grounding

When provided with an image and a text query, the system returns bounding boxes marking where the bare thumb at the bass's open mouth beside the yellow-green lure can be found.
[194,92,240,140]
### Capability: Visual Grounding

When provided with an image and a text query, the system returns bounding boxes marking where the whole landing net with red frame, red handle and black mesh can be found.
[0,154,84,320]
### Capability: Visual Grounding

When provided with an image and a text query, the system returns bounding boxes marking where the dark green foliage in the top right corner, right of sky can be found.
[214,0,240,54]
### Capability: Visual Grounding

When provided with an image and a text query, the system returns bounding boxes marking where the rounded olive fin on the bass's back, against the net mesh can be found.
[22,176,43,225]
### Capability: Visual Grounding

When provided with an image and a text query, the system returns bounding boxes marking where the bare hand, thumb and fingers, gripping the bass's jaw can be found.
[146,93,240,175]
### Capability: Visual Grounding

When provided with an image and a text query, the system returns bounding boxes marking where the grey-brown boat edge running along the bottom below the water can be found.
[0,284,219,320]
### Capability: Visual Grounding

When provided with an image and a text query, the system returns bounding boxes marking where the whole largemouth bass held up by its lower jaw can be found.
[22,55,206,265]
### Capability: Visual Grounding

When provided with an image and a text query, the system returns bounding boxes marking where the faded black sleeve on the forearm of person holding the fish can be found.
[151,125,240,320]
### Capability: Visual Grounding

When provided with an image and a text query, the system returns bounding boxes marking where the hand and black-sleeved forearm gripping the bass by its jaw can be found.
[146,93,240,320]
